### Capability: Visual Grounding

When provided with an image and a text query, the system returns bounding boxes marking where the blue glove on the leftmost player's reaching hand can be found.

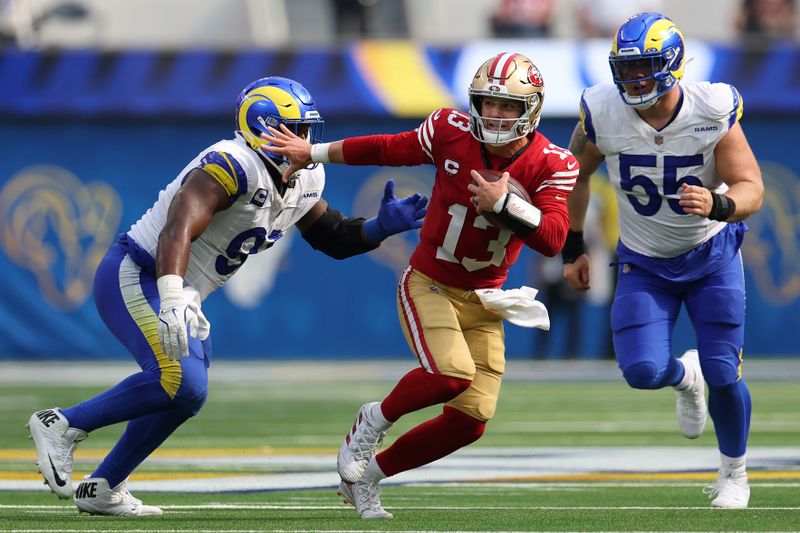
[363,180,428,244]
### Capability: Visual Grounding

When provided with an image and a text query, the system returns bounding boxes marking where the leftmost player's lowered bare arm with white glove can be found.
[156,169,228,361]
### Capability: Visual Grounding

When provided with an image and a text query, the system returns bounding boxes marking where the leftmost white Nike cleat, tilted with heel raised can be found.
[27,407,88,500]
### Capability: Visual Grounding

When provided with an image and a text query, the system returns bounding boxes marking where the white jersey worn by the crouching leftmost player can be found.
[128,137,325,299]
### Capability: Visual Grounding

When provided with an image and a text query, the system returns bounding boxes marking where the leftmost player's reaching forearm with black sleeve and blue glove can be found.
[297,180,428,259]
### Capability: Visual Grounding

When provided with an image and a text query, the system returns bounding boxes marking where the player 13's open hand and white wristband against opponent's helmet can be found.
[261,124,344,183]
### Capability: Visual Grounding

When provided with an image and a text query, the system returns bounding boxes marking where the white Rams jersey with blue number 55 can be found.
[580,82,742,258]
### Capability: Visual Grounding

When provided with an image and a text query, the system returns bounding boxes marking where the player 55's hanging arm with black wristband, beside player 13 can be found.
[561,122,603,291]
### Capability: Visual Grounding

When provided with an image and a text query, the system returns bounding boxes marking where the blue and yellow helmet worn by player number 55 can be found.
[608,13,685,109]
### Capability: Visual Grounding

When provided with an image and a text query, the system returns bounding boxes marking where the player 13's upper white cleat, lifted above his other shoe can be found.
[336,402,386,483]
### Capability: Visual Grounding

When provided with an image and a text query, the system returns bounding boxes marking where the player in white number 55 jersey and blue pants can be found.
[562,13,764,508]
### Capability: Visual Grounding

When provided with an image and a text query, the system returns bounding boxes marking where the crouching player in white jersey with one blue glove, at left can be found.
[23,77,427,516]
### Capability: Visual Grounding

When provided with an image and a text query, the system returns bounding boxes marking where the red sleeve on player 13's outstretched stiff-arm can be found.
[342,110,441,167]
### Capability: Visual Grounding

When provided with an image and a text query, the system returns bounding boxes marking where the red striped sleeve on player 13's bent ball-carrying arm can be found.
[523,149,579,257]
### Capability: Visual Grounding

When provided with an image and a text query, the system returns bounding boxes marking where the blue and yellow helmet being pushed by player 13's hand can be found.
[236,76,325,170]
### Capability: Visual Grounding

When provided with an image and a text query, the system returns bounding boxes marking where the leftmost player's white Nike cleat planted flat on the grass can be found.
[75,476,164,516]
